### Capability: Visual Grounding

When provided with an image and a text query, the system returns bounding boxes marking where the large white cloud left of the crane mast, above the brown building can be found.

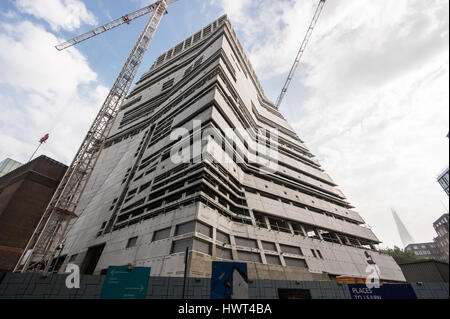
[0,21,108,164]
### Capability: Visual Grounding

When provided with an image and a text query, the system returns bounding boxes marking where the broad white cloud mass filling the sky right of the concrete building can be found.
[211,0,449,245]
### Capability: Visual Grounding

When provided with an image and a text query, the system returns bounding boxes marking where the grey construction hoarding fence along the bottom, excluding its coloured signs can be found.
[0,273,448,300]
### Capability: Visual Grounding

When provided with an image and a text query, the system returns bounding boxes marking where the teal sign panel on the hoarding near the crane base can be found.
[101,266,151,299]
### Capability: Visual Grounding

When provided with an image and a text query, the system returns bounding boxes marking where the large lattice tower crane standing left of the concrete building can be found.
[14,0,177,275]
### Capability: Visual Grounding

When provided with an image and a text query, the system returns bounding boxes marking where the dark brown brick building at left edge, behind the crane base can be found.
[0,156,67,273]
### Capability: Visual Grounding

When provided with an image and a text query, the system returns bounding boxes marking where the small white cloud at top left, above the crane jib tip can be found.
[16,0,97,31]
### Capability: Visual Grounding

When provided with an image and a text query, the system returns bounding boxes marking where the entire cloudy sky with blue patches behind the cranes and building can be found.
[0,0,449,250]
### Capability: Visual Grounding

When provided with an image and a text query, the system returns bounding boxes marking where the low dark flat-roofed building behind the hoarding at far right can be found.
[400,260,449,282]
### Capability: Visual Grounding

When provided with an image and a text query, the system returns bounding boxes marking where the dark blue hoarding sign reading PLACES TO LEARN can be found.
[348,284,417,299]
